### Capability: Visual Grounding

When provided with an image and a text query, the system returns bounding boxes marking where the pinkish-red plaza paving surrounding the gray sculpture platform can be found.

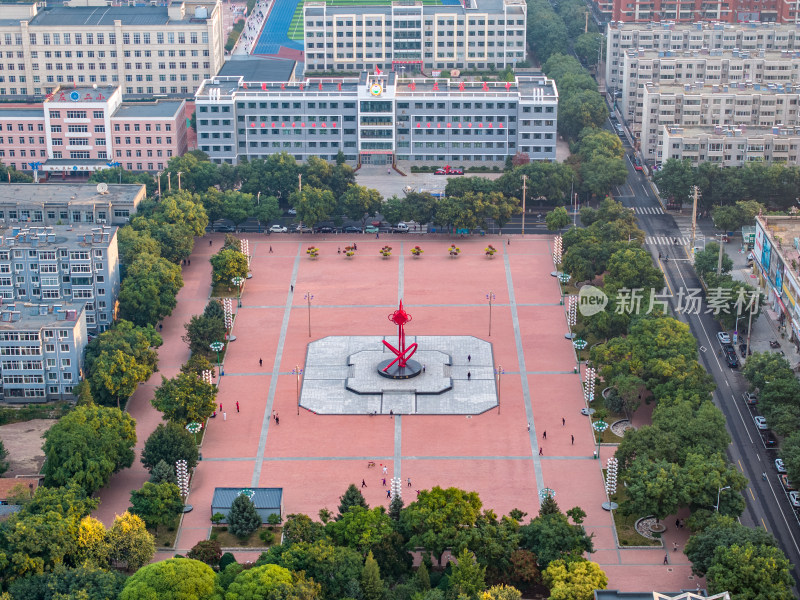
[92,234,696,591]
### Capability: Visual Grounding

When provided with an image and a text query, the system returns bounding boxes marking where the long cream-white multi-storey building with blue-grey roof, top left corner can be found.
[0,0,225,99]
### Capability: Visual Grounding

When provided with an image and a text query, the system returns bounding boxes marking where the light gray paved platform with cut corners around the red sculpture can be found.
[300,335,497,415]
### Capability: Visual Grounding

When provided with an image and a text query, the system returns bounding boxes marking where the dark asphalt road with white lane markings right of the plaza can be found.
[614,126,800,596]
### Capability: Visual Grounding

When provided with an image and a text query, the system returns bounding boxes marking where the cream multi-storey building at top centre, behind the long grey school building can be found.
[303,0,527,73]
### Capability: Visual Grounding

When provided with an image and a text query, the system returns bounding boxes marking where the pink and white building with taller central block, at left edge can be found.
[0,84,187,176]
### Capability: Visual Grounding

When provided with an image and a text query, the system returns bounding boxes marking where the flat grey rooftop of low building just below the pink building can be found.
[0,182,145,208]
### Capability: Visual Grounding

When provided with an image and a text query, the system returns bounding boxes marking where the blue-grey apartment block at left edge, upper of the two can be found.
[0,225,120,334]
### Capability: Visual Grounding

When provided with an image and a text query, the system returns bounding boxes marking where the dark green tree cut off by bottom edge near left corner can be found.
[7,565,125,600]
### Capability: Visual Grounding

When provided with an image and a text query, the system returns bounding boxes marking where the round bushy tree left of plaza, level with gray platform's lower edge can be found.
[150,373,217,426]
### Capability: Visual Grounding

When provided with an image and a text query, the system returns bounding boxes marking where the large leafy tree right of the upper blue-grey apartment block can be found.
[119,254,183,326]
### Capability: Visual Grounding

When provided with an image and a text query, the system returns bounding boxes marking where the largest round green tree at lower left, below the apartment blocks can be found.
[42,406,136,494]
